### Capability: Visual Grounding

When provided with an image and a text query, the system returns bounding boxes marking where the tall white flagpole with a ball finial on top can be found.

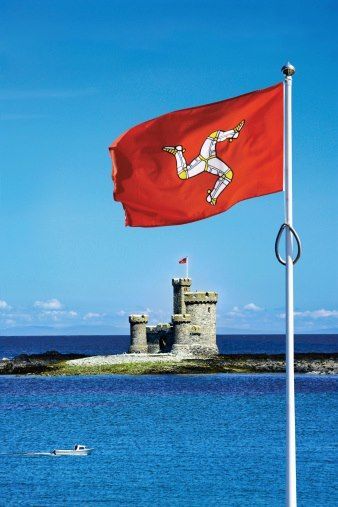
[282,63,297,507]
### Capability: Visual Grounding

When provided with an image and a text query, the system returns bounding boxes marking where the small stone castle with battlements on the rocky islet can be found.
[129,278,218,356]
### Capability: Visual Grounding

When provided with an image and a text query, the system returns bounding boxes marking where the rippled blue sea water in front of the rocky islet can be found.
[0,374,338,507]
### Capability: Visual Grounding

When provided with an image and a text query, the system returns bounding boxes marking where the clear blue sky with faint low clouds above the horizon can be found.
[0,0,338,335]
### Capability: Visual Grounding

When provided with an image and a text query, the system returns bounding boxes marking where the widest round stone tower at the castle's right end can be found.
[184,292,218,355]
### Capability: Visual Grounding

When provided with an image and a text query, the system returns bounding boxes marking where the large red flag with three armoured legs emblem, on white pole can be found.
[109,83,283,227]
